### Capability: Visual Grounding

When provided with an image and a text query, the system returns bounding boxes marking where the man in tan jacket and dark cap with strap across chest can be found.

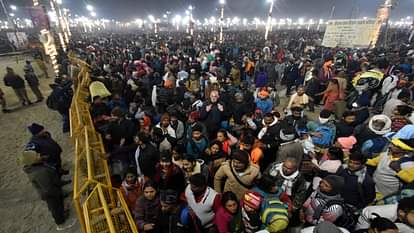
[214,150,260,200]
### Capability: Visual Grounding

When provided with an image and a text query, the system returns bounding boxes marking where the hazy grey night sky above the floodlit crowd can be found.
[1,0,414,20]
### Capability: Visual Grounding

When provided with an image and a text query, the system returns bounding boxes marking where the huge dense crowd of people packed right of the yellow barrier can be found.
[17,30,414,233]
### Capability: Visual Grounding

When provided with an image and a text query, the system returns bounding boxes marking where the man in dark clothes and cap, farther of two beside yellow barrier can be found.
[26,123,69,175]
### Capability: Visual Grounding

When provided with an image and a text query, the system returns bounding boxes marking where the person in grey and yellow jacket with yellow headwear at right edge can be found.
[367,138,414,199]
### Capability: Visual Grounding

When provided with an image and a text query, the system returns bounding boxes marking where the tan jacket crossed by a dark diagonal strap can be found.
[214,160,260,200]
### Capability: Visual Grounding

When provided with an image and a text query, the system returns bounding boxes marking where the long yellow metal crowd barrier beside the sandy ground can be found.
[69,55,138,233]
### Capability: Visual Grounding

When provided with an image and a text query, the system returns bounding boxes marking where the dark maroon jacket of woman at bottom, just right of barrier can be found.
[133,195,161,232]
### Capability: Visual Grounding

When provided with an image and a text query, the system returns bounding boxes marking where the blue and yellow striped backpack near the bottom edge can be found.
[260,197,289,226]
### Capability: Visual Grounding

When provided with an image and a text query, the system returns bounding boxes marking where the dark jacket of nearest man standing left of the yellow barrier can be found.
[23,163,62,200]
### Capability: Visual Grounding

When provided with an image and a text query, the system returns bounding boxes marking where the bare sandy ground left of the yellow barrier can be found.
[0,56,81,233]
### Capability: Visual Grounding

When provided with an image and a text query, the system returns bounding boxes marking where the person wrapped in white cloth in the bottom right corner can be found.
[356,197,414,233]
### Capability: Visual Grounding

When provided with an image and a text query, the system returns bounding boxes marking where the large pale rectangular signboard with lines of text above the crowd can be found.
[322,19,376,48]
